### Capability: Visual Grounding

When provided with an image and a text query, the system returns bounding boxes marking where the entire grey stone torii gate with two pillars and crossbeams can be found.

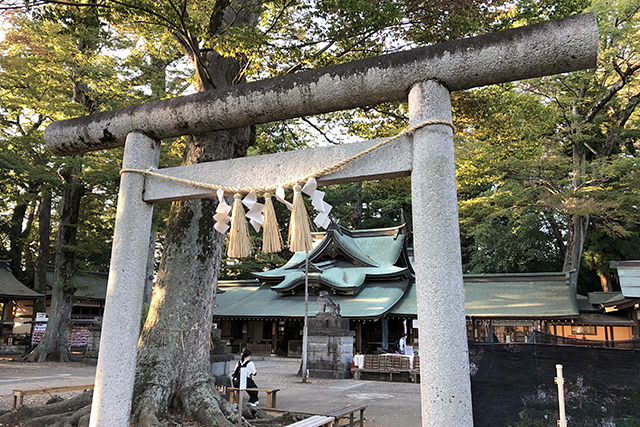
[45,14,598,427]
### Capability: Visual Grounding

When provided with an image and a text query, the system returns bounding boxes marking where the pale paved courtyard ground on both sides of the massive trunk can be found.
[0,358,421,427]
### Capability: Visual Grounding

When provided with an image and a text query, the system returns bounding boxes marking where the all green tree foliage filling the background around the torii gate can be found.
[0,0,640,290]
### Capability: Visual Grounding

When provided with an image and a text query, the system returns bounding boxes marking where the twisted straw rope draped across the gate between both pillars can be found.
[120,120,455,194]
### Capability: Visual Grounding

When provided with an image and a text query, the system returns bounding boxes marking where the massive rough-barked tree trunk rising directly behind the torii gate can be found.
[133,43,255,426]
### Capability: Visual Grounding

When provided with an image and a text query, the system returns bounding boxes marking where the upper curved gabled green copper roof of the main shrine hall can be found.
[253,226,410,294]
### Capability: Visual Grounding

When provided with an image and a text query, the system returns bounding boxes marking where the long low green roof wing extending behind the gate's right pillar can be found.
[389,273,578,319]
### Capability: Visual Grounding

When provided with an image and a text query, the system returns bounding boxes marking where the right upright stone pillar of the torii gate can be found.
[409,82,473,427]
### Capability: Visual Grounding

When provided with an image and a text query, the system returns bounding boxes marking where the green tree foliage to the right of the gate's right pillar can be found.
[453,1,640,280]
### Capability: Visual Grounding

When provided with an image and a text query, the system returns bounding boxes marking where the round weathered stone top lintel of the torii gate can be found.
[44,13,598,155]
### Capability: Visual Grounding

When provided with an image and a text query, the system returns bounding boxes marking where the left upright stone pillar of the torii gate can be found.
[91,133,160,426]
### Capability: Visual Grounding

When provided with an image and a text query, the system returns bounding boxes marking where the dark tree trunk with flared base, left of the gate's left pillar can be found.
[27,163,84,362]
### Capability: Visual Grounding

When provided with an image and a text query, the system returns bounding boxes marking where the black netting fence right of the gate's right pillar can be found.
[469,333,640,427]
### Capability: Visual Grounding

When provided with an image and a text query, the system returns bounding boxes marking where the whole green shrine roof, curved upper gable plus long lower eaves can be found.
[214,226,579,319]
